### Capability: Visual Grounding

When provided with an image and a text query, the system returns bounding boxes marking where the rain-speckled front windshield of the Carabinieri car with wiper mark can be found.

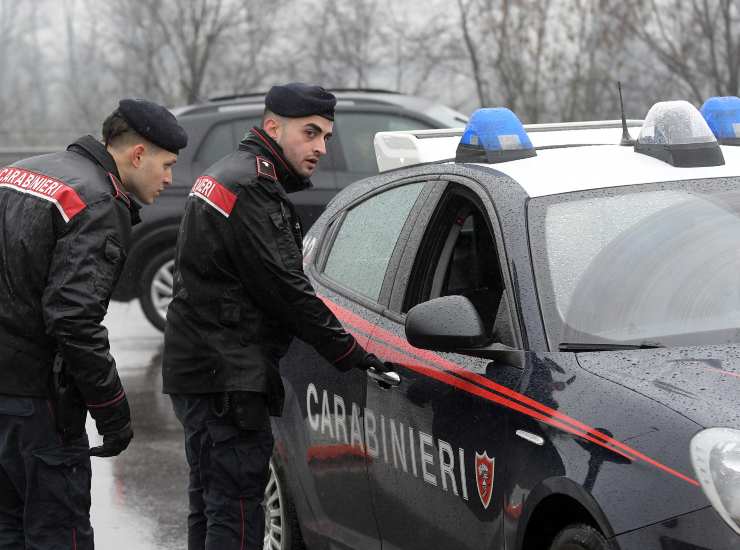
[528,178,740,349]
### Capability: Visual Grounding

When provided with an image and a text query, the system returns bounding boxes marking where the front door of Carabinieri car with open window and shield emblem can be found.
[367,182,522,550]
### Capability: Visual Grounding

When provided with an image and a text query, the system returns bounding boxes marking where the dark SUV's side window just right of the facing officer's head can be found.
[334,113,431,174]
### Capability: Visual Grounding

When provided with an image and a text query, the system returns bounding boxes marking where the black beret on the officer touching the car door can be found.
[265,82,337,120]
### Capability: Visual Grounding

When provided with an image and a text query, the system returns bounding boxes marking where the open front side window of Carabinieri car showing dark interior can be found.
[405,197,515,347]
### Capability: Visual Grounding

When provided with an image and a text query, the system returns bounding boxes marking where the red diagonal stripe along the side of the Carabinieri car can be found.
[321,296,699,487]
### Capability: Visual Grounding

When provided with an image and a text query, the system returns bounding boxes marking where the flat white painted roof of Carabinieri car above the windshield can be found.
[481,145,740,197]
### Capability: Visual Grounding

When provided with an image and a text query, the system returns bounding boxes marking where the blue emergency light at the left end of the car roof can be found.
[455,107,537,163]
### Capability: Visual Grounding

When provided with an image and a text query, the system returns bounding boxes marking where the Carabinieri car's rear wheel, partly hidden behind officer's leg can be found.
[262,460,305,550]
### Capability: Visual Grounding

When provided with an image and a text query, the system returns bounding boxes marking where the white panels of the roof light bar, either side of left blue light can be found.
[375,120,642,172]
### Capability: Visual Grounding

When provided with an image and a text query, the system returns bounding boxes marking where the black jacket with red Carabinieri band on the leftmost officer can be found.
[0,136,138,417]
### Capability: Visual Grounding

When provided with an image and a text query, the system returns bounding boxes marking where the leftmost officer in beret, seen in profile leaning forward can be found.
[0,99,187,550]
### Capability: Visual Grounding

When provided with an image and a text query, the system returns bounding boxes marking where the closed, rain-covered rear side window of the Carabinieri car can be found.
[324,183,424,301]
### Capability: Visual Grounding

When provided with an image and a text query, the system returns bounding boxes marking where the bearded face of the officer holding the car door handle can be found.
[266,116,334,178]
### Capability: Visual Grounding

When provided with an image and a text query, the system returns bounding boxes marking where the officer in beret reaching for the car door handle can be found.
[163,83,387,550]
